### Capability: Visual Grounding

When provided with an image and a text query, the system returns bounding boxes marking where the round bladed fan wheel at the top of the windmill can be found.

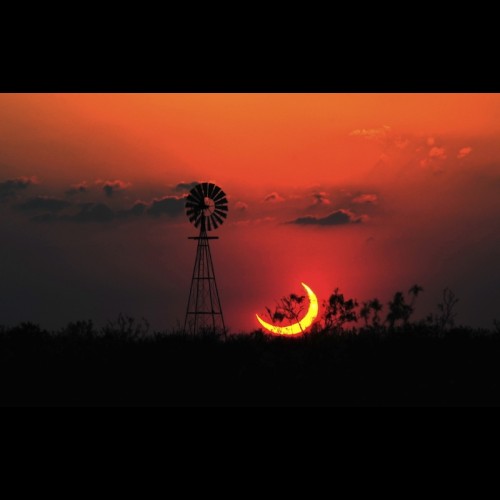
[186,182,229,231]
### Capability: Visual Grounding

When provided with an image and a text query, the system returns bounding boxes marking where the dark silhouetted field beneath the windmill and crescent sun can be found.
[0,322,500,406]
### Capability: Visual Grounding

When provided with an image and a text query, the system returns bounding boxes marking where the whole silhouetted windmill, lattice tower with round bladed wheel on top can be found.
[184,182,228,335]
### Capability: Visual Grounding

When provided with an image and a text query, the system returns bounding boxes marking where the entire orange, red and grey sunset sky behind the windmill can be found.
[0,94,500,332]
